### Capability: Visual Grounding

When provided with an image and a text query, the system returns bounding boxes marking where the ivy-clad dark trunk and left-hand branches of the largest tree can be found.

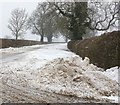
[53,2,88,40]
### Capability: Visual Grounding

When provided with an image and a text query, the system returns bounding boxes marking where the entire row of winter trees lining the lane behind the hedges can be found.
[8,2,120,42]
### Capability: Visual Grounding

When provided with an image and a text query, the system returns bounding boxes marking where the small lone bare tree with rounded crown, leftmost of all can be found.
[8,9,27,40]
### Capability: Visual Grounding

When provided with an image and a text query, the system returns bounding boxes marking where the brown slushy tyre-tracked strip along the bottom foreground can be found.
[2,84,109,103]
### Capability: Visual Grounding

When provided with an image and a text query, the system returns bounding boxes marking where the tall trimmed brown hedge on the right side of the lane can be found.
[68,31,120,69]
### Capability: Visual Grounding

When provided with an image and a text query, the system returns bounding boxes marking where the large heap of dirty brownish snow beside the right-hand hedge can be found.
[36,56,118,102]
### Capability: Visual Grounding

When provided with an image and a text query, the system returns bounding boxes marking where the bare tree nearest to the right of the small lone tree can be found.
[28,2,49,42]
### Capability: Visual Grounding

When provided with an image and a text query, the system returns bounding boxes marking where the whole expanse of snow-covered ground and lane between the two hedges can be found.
[0,44,119,103]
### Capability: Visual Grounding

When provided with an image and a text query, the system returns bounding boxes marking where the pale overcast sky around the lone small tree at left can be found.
[0,0,116,40]
